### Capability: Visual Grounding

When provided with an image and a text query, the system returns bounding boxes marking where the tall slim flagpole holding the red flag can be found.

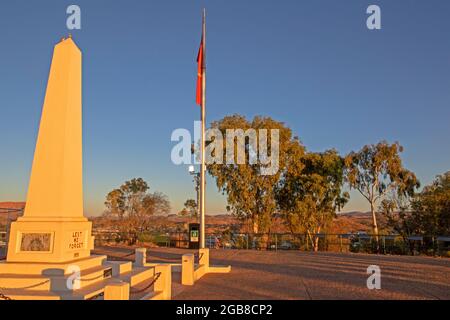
[200,9,206,249]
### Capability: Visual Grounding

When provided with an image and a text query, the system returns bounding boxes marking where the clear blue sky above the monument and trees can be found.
[0,0,450,215]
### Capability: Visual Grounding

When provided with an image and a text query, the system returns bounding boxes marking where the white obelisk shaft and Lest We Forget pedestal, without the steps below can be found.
[7,37,93,263]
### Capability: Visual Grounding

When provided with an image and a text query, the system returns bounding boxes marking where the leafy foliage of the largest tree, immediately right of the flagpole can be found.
[207,115,294,232]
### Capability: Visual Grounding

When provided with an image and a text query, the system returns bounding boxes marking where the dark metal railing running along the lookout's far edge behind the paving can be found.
[91,232,450,256]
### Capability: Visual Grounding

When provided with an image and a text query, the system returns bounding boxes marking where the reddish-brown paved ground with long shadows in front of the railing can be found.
[98,248,450,300]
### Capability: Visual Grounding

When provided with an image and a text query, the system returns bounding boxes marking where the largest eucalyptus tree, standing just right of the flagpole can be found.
[206,114,295,233]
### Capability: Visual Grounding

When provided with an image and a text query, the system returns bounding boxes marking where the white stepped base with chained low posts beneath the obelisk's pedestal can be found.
[0,250,171,300]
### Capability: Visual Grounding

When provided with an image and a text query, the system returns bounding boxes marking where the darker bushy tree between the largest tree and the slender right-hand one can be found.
[276,148,349,250]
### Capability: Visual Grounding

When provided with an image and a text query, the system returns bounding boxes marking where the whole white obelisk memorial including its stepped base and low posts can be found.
[0,37,172,300]
